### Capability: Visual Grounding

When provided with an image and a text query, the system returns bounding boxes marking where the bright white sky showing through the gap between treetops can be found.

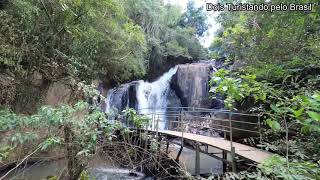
[165,0,220,47]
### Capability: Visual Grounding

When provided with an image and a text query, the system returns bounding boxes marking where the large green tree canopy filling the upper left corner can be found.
[0,0,146,82]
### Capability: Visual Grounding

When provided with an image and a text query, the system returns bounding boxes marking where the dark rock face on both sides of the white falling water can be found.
[105,61,223,111]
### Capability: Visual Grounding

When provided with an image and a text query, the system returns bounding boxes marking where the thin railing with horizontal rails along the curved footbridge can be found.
[138,107,262,150]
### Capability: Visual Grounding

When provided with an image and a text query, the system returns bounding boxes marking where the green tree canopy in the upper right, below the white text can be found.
[211,0,320,66]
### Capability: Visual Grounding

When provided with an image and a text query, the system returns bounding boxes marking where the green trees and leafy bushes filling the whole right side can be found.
[210,0,320,179]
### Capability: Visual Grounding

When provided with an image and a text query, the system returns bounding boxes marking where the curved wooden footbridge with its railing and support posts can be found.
[124,107,272,175]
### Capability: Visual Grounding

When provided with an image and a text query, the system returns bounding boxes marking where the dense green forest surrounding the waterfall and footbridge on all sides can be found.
[0,0,320,180]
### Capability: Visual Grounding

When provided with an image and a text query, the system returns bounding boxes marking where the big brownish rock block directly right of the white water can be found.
[171,63,213,108]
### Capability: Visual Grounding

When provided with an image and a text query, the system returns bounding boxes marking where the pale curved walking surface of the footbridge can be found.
[159,130,272,163]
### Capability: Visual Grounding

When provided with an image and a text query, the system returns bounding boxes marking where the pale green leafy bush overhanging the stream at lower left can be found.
[0,102,112,160]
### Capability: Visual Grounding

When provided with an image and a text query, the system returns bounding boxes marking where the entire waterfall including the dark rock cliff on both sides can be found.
[105,62,223,129]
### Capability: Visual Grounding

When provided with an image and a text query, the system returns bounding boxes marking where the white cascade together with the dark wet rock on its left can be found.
[105,67,178,129]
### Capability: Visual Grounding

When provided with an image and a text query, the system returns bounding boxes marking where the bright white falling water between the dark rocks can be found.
[136,67,177,129]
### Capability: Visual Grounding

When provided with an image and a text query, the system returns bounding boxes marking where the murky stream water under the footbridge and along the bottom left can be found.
[0,145,222,180]
